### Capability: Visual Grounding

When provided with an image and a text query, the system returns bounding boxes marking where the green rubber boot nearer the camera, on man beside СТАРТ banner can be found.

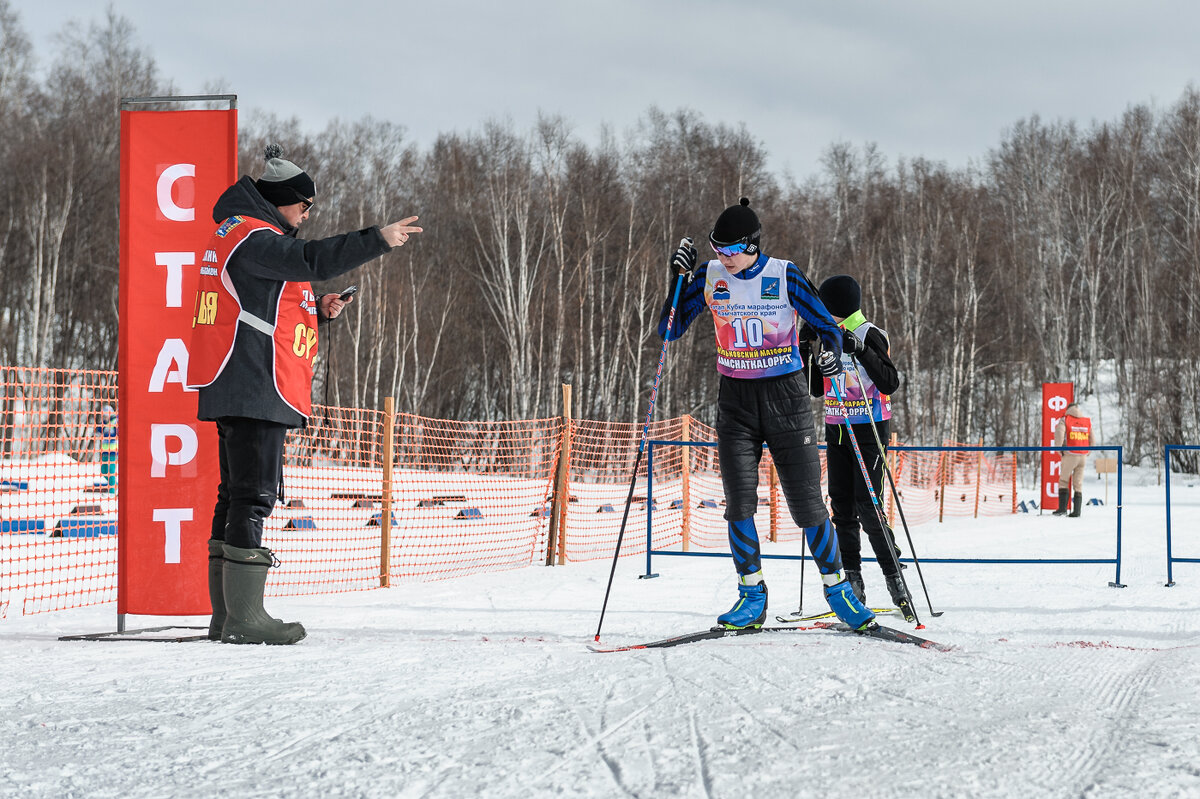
[221,543,307,644]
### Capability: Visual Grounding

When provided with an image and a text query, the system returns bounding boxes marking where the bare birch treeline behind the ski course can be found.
[0,6,1200,461]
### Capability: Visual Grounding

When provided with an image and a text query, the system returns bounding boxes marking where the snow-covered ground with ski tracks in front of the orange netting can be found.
[0,470,1200,799]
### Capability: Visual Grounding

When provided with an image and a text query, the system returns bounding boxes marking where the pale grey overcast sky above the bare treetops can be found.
[13,0,1200,178]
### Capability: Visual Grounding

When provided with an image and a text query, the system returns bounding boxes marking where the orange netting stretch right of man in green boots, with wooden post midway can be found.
[264,407,560,595]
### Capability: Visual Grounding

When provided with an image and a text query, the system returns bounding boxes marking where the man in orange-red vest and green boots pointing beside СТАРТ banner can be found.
[187,145,421,644]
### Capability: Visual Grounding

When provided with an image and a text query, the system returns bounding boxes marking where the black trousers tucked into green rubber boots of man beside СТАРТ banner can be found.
[211,416,288,549]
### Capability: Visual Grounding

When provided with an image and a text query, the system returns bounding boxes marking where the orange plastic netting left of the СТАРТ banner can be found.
[0,367,118,618]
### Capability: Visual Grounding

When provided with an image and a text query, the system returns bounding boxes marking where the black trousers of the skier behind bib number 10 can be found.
[826,421,899,575]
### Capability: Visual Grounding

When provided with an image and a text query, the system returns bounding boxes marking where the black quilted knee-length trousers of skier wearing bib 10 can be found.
[716,372,829,529]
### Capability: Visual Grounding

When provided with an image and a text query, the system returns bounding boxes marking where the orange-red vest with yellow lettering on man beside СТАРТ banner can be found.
[187,216,317,417]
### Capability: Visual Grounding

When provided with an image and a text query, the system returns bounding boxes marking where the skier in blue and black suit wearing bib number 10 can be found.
[659,197,875,630]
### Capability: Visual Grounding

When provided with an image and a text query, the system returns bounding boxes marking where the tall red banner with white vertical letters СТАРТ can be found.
[116,109,238,615]
